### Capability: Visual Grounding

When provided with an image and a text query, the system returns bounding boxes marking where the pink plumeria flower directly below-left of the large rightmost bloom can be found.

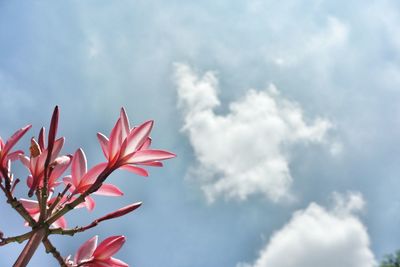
[63,149,123,210]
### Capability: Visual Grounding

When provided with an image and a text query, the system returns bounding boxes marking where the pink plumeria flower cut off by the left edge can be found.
[0,125,32,178]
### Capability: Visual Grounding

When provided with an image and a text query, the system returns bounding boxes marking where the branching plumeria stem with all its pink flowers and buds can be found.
[0,107,175,267]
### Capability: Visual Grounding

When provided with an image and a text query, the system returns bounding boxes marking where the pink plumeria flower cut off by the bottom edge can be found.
[67,236,129,267]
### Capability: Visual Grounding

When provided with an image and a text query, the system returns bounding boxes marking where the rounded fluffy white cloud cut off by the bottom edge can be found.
[237,193,375,267]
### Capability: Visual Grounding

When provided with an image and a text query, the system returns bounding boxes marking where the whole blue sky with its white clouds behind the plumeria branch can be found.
[0,0,400,267]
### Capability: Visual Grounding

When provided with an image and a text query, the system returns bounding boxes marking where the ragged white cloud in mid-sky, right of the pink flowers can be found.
[176,64,331,201]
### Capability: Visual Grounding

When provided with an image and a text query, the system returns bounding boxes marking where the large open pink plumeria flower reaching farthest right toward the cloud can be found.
[97,108,176,176]
